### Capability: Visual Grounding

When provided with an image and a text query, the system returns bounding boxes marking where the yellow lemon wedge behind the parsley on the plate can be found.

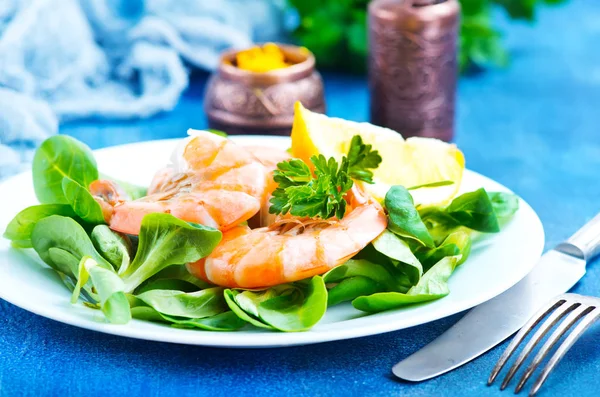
[292,102,465,206]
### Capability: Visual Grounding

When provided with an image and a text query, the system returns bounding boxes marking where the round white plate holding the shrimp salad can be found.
[0,136,544,347]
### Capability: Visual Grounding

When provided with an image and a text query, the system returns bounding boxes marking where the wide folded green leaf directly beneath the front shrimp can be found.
[225,276,327,332]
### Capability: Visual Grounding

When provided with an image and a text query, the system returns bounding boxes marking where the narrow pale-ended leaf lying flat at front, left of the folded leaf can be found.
[137,287,229,319]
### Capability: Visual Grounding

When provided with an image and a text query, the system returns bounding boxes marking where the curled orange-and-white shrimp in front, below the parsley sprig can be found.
[187,186,387,288]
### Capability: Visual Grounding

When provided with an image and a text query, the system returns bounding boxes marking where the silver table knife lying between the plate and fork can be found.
[392,214,600,382]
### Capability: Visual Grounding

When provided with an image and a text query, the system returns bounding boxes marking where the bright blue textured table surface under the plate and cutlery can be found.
[0,0,600,397]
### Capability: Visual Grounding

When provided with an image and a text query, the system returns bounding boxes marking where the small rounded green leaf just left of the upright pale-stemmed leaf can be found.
[90,225,133,274]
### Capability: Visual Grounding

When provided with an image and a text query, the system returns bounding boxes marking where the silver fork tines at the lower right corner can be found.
[488,294,600,396]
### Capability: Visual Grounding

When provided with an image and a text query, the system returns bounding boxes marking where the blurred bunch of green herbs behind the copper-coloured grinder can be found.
[288,0,565,72]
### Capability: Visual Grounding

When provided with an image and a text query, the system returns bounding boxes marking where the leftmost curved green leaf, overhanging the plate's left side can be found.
[4,204,76,248]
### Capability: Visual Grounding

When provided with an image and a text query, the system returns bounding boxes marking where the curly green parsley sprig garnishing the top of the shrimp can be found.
[269,135,381,219]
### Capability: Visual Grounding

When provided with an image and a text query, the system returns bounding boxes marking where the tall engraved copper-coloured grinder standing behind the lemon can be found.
[368,0,460,141]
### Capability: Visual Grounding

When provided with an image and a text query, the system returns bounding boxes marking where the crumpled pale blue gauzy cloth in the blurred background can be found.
[0,0,284,178]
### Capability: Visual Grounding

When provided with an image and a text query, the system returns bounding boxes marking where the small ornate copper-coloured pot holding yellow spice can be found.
[204,44,325,135]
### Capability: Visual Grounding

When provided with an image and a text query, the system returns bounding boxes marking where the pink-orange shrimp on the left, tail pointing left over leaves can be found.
[90,130,269,234]
